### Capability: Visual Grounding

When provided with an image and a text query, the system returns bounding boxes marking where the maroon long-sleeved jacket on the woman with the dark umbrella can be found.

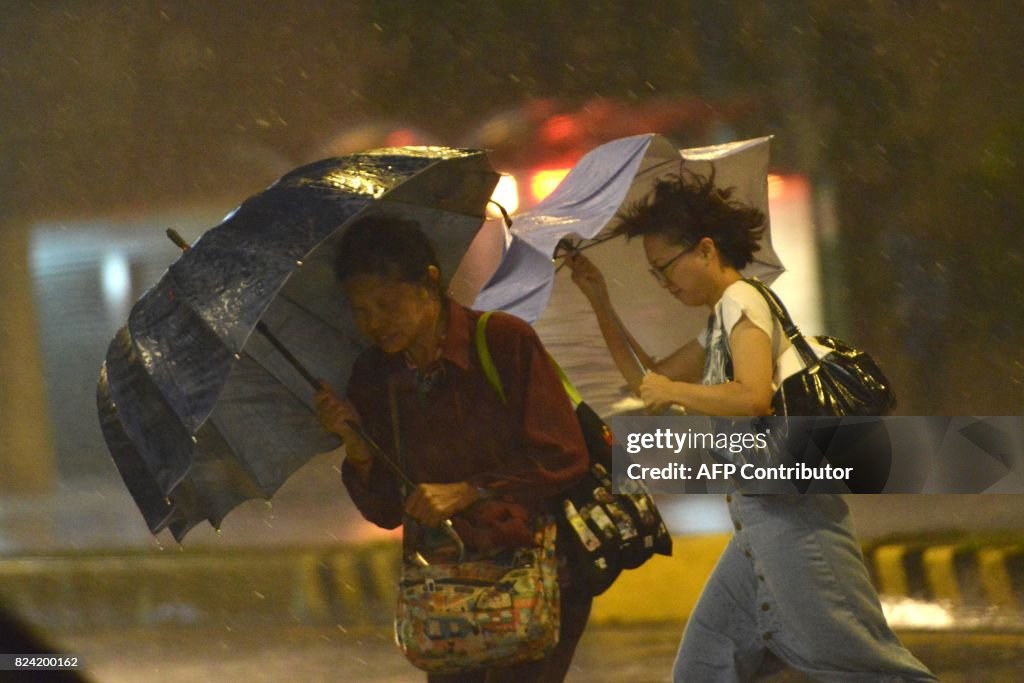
[342,302,588,528]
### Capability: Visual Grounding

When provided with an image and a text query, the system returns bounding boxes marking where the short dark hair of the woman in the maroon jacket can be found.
[334,213,440,283]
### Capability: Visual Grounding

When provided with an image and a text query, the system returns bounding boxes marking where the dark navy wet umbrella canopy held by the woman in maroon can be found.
[96,147,498,540]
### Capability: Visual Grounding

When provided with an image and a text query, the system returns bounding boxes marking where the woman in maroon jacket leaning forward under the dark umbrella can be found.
[317,215,591,683]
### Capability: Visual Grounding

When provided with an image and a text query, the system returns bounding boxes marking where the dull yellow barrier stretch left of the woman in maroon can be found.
[0,543,399,632]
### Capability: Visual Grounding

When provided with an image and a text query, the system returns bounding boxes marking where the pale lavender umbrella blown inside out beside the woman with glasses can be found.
[474,134,783,409]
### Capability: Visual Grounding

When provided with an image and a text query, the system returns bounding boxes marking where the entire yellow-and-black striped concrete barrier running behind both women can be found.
[0,535,1024,632]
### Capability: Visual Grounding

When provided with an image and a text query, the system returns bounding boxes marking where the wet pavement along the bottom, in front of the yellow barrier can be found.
[49,624,1024,683]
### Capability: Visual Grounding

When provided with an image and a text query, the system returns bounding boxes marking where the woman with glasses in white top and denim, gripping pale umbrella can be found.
[566,175,936,683]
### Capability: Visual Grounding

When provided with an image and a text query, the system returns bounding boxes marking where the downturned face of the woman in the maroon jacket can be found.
[344,274,437,353]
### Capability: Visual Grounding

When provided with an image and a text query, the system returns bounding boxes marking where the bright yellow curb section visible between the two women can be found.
[591,533,732,624]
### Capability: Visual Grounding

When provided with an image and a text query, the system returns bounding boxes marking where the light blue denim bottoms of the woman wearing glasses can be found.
[673,495,938,683]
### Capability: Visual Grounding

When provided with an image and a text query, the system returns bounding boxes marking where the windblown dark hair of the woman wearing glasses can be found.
[614,167,765,269]
